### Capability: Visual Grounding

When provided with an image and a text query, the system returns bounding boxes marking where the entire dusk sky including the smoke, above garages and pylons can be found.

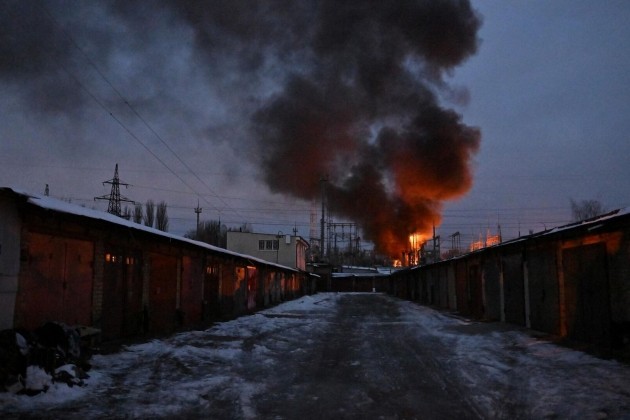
[0,0,630,256]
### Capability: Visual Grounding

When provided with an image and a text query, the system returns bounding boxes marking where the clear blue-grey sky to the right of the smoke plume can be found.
[442,1,630,243]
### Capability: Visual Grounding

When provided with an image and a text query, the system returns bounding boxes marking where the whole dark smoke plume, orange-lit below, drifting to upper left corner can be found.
[0,0,481,256]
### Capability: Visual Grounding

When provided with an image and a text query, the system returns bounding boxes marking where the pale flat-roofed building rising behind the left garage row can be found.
[227,231,309,270]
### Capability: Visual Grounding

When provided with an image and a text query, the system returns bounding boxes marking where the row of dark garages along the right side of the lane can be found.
[386,211,630,348]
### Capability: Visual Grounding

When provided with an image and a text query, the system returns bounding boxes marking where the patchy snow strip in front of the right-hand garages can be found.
[402,304,630,419]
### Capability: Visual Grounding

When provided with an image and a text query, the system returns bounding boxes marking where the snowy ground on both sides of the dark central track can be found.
[0,293,630,419]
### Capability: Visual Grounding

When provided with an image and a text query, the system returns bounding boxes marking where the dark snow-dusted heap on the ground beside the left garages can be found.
[0,322,96,395]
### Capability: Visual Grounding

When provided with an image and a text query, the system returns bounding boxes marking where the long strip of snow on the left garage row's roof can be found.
[0,187,299,271]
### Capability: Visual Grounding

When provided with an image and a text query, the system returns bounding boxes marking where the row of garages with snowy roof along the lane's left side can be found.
[0,188,317,339]
